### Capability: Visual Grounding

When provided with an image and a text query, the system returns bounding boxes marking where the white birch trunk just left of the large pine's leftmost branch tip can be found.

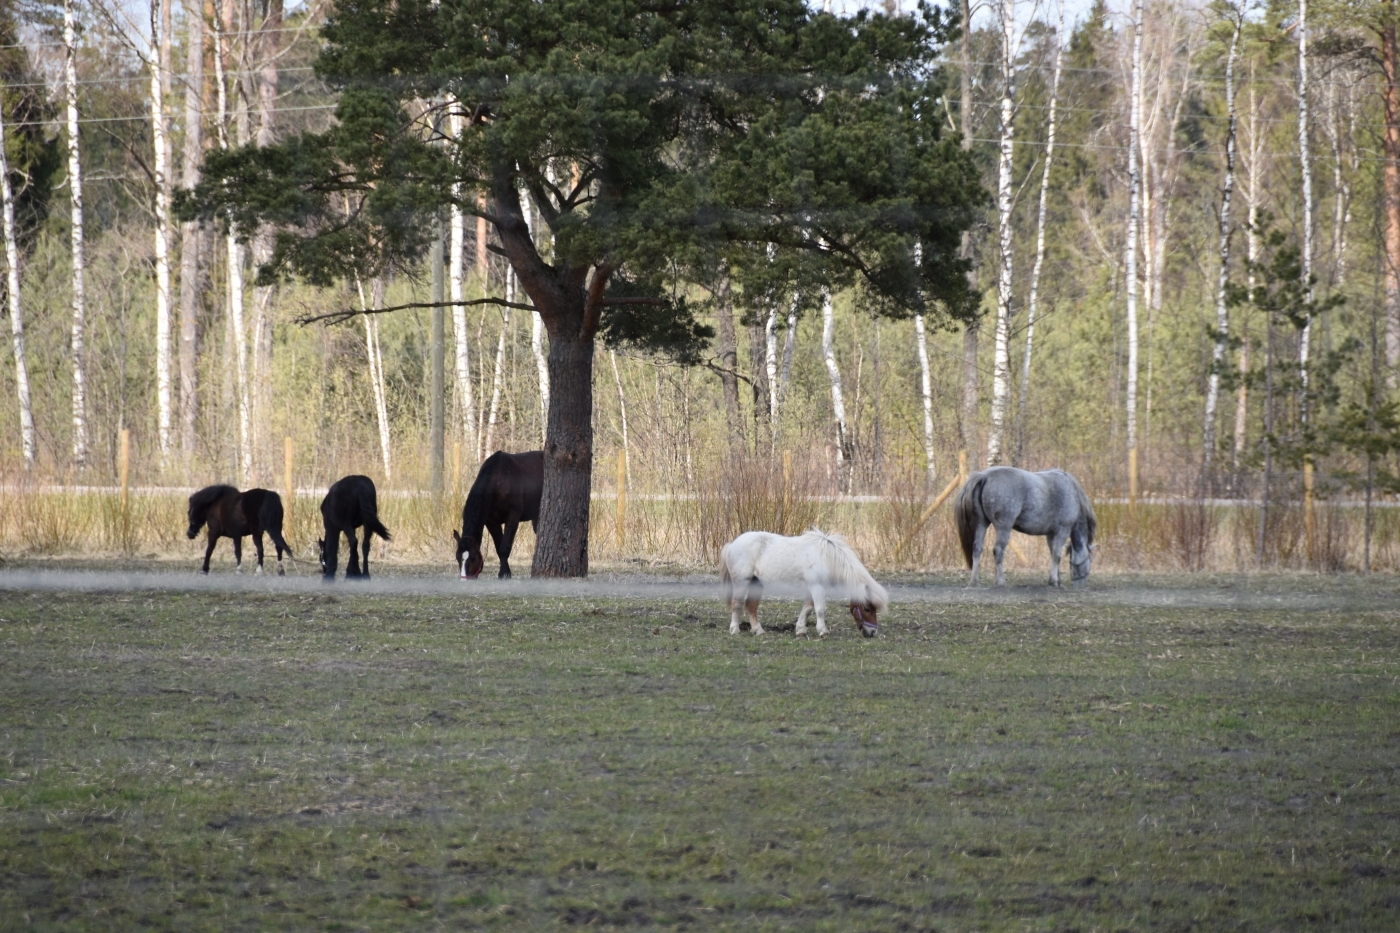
[150,0,174,465]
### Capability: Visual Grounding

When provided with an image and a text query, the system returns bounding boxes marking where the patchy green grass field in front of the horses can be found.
[0,563,1400,932]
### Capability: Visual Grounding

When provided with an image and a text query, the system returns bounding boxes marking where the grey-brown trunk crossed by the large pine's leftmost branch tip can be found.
[179,0,204,458]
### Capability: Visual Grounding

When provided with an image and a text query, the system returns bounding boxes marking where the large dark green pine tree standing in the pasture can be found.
[183,0,986,576]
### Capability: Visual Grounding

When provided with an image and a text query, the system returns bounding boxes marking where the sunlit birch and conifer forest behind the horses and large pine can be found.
[0,0,1400,573]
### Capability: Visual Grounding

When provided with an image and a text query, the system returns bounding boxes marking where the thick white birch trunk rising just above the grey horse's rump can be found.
[987,0,1021,467]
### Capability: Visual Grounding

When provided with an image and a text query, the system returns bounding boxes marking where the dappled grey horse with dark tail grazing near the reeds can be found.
[953,467,1096,587]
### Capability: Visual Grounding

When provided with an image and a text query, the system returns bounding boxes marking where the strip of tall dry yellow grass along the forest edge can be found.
[0,457,1400,573]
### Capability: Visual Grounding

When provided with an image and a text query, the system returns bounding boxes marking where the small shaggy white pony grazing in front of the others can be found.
[720,528,889,637]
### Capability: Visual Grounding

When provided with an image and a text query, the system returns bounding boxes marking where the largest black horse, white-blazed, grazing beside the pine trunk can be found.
[452,450,545,580]
